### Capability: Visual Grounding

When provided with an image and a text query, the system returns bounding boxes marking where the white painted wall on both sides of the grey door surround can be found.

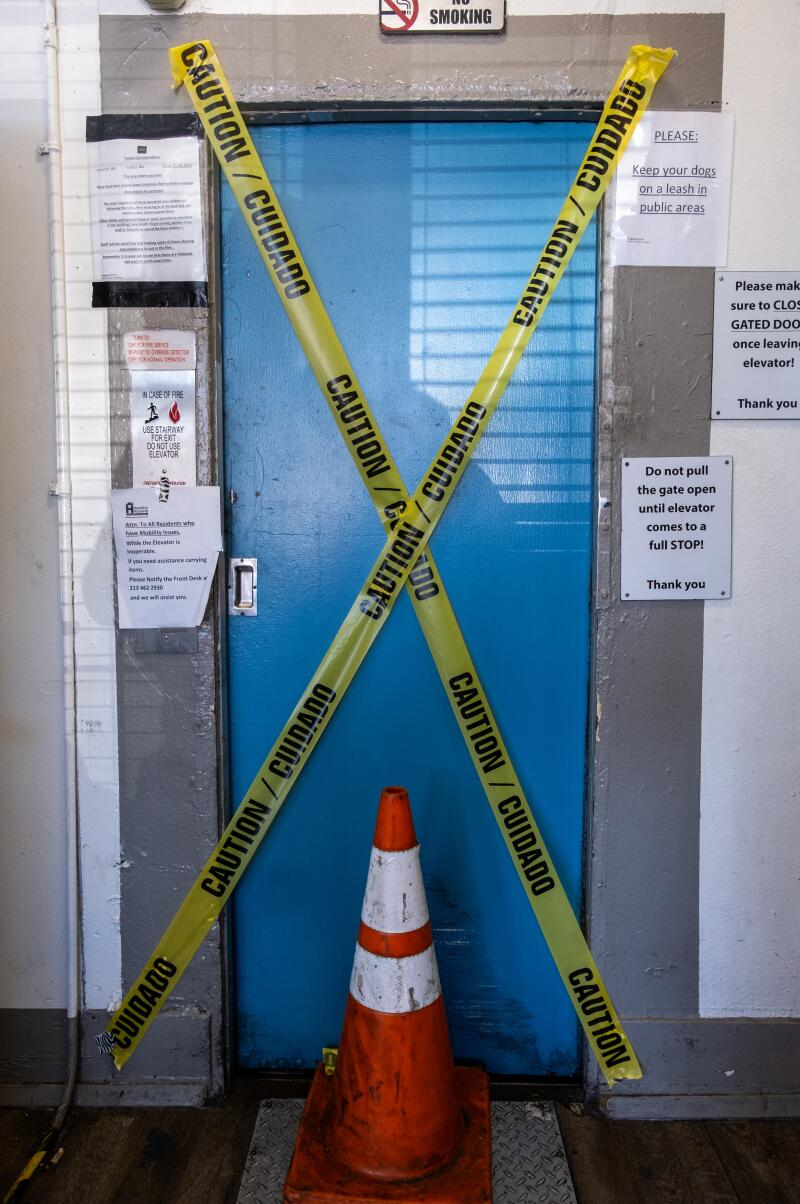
[0,0,800,1016]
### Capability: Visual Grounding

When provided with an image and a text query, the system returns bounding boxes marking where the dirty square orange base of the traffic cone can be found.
[283,1067,492,1204]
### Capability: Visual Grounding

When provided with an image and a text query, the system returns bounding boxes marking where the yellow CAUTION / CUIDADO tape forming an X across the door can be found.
[99,41,675,1082]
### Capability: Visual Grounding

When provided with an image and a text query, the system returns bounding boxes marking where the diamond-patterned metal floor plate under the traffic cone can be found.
[237,1099,576,1204]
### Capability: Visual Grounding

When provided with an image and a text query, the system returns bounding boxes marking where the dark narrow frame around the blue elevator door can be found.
[214,108,613,1098]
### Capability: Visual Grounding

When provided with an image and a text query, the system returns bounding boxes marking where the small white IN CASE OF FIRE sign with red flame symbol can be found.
[130,371,198,488]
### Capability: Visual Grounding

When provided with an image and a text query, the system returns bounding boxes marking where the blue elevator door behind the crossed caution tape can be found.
[222,123,596,1075]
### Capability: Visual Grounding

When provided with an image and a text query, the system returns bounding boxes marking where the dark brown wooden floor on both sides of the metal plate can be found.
[0,1085,800,1204]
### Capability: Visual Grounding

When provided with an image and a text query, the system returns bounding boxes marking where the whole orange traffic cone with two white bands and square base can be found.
[283,786,492,1204]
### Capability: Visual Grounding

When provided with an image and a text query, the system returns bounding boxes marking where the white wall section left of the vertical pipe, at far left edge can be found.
[0,0,66,1008]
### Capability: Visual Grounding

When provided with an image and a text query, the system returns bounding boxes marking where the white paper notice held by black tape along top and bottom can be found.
[88,137,206,281]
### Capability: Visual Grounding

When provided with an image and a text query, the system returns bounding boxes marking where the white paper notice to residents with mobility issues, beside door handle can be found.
[111,485,222,627]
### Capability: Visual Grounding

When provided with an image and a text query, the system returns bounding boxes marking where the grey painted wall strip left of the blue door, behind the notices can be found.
[109,293,225,1097]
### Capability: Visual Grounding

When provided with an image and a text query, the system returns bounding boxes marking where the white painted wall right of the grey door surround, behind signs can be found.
[700,0,800,1016]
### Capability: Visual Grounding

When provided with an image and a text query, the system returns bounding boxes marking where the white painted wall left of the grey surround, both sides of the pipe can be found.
[0,0,120,1008]
